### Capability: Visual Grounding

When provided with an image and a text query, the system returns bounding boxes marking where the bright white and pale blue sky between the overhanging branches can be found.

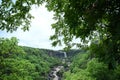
[0,5,63,50]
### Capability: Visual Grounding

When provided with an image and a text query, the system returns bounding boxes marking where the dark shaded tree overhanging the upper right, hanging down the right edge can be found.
[46,0,120,69]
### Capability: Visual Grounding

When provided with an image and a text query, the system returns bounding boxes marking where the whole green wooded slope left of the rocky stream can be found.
[0,37,60,80]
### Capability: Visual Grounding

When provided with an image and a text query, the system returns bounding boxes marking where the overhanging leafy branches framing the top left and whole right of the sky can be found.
[0,0,120,69]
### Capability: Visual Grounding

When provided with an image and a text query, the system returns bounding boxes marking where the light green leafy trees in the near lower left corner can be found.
[0,37,35,80]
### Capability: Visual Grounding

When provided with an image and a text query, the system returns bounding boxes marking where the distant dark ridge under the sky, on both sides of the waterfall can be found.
[21,46,83,58]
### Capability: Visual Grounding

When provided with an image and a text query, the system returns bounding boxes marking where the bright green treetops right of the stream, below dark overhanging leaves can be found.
[63,46,120,80]
